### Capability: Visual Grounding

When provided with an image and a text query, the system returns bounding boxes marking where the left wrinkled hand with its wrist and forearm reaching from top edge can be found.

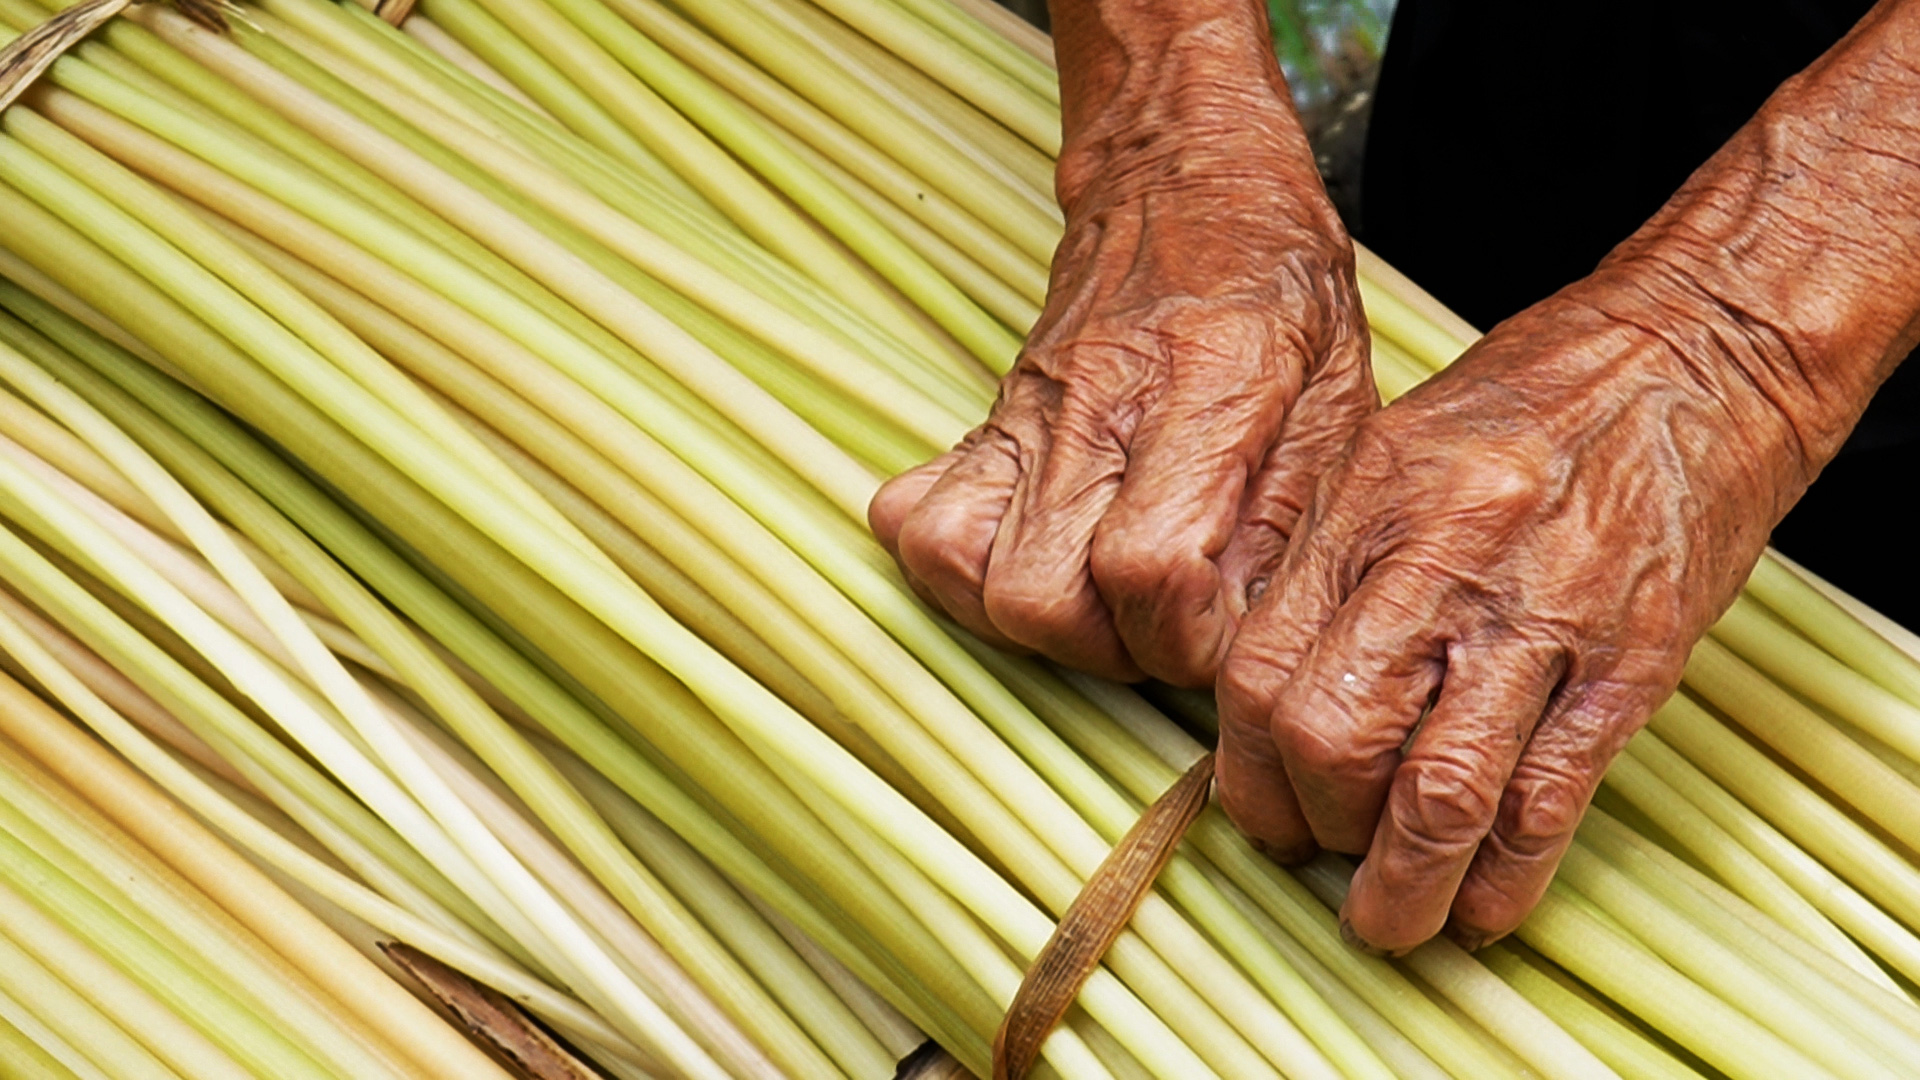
[872,0,1377,686]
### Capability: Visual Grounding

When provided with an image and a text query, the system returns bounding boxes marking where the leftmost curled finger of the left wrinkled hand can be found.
[890,429,1020,648]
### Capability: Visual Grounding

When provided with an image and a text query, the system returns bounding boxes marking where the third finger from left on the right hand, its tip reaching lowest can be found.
[1342,644,1563,953]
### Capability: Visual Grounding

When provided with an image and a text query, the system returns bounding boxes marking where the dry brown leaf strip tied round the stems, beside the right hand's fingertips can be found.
[993,753,1213,1080]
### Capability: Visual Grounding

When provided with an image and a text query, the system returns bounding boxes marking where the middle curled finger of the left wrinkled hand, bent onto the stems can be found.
[983,344,1140,682]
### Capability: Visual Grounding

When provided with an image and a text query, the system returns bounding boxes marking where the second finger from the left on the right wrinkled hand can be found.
[1273,563,1448,855]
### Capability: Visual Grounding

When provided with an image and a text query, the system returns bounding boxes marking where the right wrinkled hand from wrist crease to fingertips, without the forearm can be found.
[1219,261,1807,951]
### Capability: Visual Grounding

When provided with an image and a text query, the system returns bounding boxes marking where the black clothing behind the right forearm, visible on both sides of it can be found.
[1356,0,1920,626]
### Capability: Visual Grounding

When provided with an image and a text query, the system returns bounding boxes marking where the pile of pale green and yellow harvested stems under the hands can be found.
[0,0,1920,1080]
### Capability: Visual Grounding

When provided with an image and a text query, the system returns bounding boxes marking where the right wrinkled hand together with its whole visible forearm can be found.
[1219,0,1920,951]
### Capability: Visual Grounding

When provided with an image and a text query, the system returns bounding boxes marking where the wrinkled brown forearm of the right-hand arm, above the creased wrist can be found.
[1596,0,1920,486]
